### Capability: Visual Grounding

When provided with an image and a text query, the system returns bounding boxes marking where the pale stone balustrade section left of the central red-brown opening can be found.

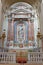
[0,52,16,63]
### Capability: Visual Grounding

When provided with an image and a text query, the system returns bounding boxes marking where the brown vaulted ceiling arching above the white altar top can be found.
[1,0,41,10]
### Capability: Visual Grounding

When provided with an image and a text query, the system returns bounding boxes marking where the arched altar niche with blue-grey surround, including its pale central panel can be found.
[14,21,29,44]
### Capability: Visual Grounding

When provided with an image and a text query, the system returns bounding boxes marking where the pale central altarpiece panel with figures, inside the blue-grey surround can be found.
[17,23,26,43]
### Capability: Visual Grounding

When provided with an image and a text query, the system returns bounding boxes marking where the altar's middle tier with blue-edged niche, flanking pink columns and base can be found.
[7,19,34,48]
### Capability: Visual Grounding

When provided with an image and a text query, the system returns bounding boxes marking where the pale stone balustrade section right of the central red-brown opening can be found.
[28,52,43,63]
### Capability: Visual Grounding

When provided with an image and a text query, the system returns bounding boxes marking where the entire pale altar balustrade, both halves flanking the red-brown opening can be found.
[0,52,43,63]
